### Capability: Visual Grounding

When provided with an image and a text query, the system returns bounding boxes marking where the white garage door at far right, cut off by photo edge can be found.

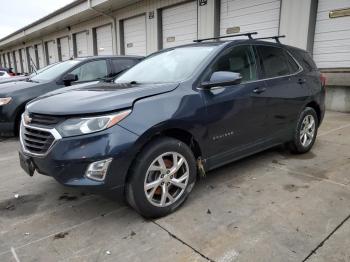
[313,0,350,68]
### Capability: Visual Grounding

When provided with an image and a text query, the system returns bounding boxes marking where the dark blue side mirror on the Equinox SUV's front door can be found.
[201,71,242,89]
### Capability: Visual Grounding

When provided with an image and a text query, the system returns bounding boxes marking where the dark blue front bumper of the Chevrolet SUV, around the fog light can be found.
[20,125,138,196]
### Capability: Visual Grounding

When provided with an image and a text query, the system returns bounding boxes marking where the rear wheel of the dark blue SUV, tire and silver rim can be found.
[288,107,319,154]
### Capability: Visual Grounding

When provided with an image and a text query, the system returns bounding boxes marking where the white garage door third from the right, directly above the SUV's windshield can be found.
[162,1,197,48]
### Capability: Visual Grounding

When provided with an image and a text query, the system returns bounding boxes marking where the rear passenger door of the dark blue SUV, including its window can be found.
[256,45,309,138]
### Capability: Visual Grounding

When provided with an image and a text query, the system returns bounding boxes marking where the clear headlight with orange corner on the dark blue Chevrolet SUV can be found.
[57,110,131,137]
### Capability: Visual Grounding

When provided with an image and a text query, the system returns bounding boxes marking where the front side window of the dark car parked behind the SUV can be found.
[71,60,108,82]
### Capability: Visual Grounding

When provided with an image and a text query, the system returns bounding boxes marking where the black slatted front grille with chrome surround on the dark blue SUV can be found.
[21,126,55,155]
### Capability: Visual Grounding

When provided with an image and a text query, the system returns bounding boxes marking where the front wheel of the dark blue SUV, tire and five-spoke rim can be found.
[126,137,197,218]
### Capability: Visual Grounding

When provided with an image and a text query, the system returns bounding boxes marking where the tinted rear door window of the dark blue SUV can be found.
[257,46,290,78]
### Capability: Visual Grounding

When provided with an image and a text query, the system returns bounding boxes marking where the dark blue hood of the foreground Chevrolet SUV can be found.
[27,83,178,115]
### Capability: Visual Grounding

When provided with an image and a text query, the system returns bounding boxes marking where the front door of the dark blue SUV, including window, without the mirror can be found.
[202,45,267,159]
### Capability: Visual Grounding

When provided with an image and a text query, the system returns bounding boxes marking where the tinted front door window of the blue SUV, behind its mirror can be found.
[210,46,257,82]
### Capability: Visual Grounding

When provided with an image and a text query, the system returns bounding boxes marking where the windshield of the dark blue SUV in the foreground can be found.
[115,46,215,83]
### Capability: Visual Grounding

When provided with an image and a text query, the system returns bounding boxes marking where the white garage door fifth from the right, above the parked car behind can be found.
[96,25,113,55]
